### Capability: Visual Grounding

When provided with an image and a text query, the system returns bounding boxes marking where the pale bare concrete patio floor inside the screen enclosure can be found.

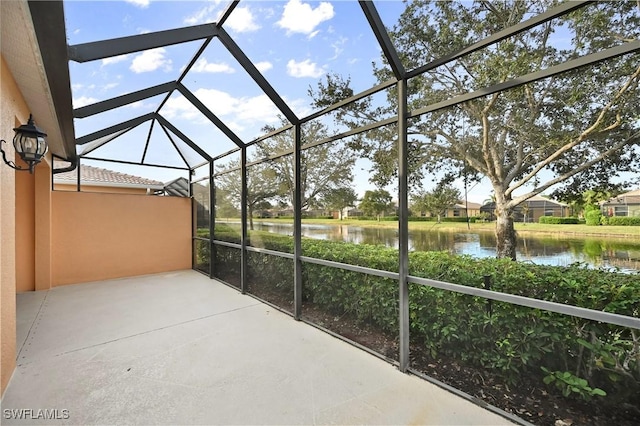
[1,271,511,425]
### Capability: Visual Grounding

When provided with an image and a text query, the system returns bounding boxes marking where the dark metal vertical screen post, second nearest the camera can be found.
[293,123,302,321]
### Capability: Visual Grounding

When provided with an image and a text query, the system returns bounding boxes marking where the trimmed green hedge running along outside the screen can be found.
[205,225,640,408]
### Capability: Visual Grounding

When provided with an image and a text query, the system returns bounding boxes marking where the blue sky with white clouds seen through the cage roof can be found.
[65,0,496,202]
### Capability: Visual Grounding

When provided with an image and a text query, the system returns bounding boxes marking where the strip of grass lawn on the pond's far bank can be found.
[249,218,640,241]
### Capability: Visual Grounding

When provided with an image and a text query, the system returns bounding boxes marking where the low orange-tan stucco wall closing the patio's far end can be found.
[51,191,191,286]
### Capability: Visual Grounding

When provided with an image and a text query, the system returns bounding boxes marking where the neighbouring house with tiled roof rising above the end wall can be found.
[53,165,165,194]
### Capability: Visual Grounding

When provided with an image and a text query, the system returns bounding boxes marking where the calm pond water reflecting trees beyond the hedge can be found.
[242,222,640,272]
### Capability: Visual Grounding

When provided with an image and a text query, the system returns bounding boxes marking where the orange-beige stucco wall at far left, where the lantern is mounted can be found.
[0,56,29,394]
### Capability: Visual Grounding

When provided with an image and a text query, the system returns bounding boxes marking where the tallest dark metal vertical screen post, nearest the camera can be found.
[398,78,409,373]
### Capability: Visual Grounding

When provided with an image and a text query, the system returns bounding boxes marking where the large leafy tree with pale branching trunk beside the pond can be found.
[310,0,640,259]
